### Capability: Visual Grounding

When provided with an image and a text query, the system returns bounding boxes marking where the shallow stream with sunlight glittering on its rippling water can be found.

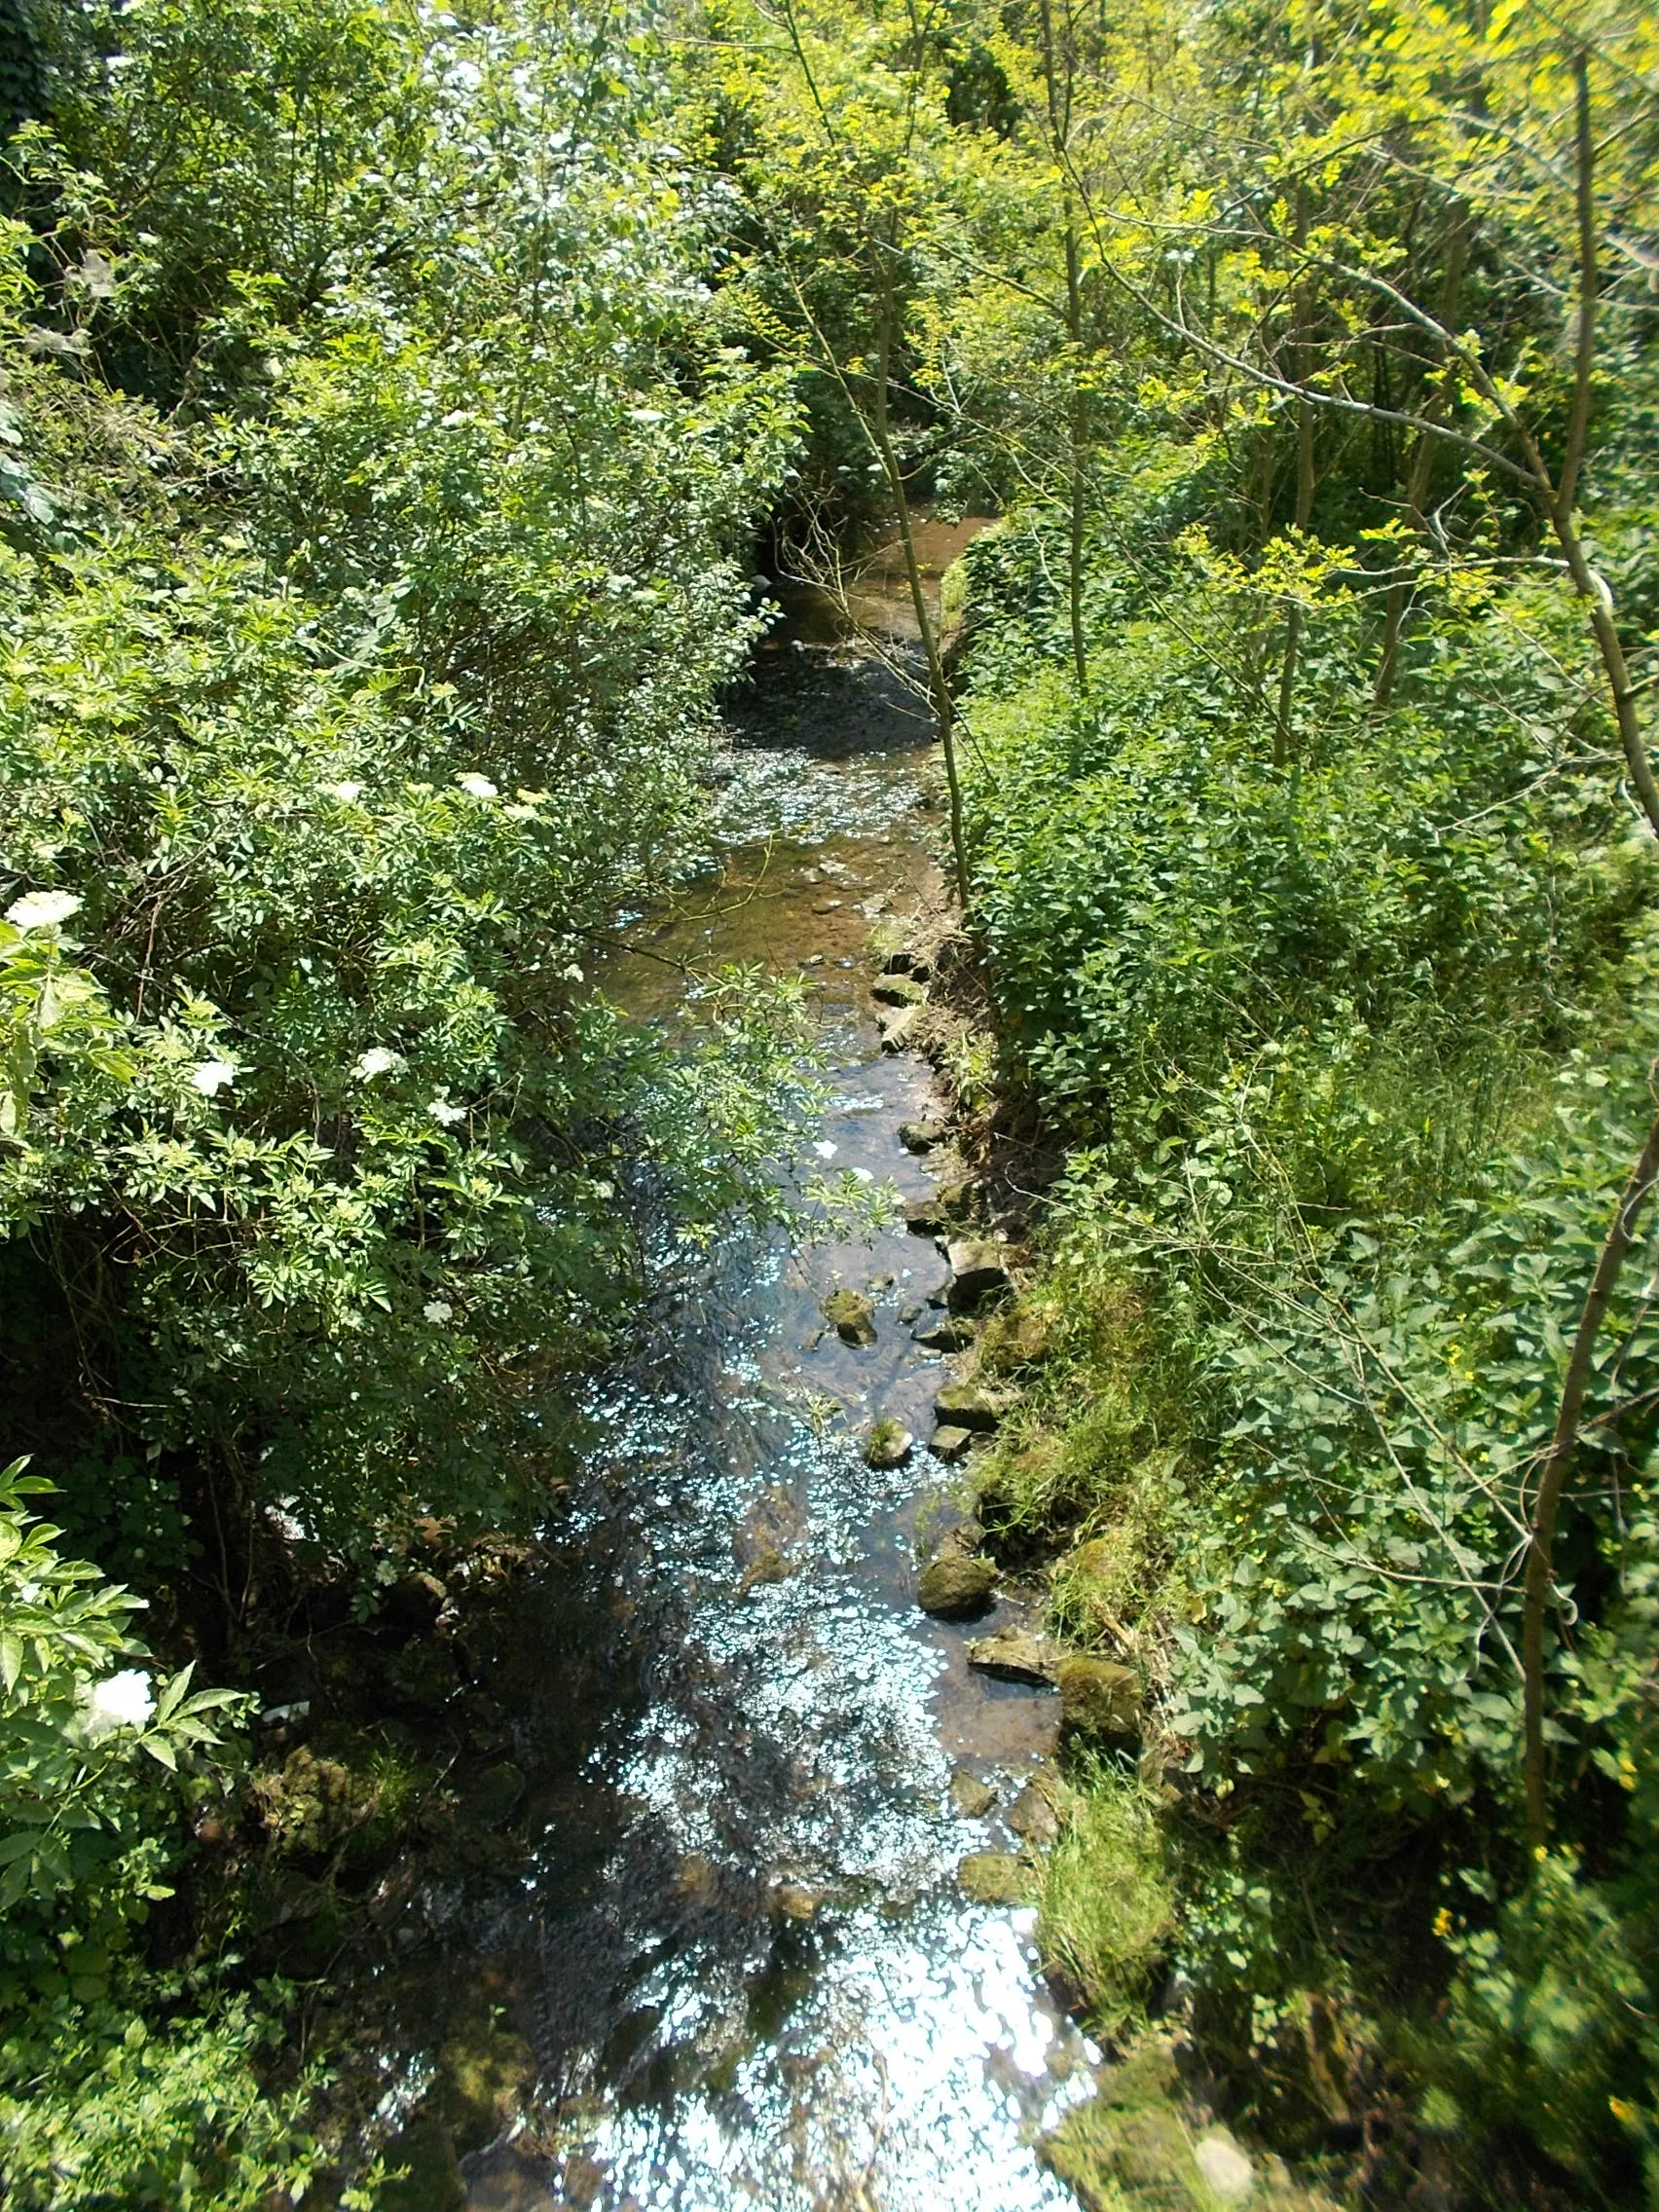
[413,531,1097,2212]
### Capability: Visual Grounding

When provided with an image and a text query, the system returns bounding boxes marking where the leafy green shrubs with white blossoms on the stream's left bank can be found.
[0,0,796,2205]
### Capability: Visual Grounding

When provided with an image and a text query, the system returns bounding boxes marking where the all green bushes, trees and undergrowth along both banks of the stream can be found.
[0,0,1659,2205]
